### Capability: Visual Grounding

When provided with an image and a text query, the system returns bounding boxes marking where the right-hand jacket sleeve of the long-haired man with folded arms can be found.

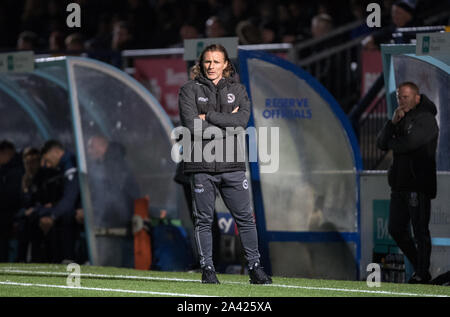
[206,85,250,129]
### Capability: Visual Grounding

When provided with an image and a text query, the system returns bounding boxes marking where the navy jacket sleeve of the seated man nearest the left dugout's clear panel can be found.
[38,169,80,219]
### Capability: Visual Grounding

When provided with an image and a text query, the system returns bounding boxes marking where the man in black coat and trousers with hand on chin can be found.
[377,82,439,283]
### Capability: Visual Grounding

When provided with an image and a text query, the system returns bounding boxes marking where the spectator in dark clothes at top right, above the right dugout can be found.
[362,0,423,50]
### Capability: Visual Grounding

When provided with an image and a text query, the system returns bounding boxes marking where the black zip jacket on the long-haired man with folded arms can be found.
[178,71,250,173]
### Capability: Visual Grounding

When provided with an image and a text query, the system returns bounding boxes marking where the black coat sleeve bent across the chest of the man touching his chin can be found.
[388,113,439,153]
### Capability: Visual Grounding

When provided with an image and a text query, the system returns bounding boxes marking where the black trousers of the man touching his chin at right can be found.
[389,192,431,278]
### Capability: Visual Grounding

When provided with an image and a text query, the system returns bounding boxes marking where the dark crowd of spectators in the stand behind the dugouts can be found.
[0,0,408,52]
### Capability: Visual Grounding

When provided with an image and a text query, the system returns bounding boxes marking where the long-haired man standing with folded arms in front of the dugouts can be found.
[179,44,272,284]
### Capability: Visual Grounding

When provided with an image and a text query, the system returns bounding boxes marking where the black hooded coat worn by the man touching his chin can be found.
[377,95,439,199]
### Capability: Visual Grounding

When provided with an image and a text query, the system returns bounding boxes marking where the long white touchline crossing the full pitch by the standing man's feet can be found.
[0,269,450,297]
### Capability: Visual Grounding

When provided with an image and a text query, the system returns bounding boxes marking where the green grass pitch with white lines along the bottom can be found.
[0,263,450,298]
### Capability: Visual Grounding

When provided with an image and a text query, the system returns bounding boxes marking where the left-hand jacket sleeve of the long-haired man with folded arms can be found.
[178,85,220,139]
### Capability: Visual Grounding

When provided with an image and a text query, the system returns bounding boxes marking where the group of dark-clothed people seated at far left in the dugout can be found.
[0,140,87,263]
